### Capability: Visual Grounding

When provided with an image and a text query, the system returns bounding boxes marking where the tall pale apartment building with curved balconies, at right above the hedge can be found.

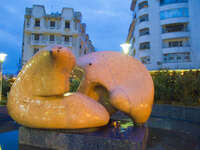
[127,0,200,70]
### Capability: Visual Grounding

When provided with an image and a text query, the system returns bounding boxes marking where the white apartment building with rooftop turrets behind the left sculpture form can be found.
[22,5,95,65]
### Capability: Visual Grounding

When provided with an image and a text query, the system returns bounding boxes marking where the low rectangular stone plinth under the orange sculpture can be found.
[19,120,147,150]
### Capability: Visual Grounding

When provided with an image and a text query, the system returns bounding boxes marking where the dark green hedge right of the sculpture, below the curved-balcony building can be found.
[152,71,200,105]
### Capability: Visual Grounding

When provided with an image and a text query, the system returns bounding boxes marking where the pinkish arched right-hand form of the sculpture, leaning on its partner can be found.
[77,51,154,124]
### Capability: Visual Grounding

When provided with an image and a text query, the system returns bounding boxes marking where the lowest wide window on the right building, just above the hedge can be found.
[164,52,190,63]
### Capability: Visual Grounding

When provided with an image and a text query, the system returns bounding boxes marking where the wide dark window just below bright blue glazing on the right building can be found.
[162,23,188,33]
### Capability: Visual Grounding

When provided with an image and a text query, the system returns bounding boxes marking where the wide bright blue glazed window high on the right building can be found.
[160,8,189,20]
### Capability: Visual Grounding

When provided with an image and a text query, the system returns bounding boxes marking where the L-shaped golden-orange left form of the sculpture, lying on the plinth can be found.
[7,46,110,129]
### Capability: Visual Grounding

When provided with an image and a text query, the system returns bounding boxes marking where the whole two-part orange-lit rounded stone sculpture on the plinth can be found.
[7,46,154,129]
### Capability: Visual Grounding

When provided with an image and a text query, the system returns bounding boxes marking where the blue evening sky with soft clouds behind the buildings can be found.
[0,0,131,73]
